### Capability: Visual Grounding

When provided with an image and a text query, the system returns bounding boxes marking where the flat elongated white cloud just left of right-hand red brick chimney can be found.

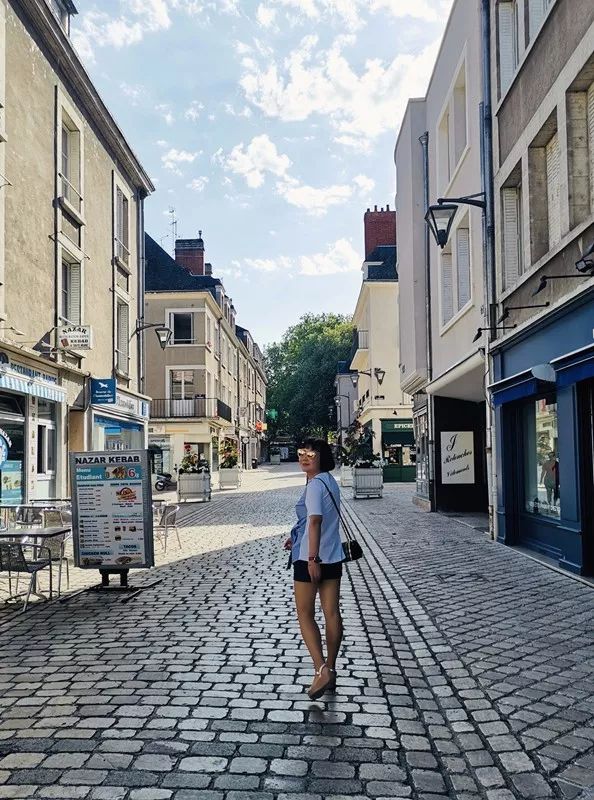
[234,238,361,277]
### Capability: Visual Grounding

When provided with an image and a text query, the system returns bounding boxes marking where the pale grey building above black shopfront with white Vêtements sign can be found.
[395,0,488,511]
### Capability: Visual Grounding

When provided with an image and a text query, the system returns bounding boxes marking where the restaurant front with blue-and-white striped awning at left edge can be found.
[0,351,65,505]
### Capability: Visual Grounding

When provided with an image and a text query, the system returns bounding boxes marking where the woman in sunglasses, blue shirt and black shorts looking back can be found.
[285,438,344,700]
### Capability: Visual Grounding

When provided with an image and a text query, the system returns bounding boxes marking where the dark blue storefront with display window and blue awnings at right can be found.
[491,291,594,575]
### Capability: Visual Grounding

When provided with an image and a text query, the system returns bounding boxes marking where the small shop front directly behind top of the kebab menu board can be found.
[91,389,149,451]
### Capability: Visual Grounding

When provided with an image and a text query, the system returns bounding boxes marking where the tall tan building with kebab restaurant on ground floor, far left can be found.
[0,0,153,502]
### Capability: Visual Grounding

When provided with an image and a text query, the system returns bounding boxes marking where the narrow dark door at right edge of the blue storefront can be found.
[578,381,594,575]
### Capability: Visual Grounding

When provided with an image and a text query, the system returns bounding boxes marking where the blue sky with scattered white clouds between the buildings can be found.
[72,0,452,346]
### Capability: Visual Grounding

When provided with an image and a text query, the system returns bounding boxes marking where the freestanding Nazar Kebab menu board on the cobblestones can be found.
[70,450,155,569]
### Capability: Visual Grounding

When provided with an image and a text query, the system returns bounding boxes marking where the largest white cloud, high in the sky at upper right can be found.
[241,36,439,150]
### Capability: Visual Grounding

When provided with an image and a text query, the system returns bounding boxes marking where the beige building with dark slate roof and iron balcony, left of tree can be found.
[145,235,266,474]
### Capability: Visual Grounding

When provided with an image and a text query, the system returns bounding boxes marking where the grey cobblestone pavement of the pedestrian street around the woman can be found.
[0,467,594,800]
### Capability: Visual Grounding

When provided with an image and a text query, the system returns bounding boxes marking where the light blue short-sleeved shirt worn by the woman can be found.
[291,472,344,564]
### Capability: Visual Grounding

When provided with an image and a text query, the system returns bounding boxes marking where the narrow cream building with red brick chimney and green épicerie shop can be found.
[350,206,415,481]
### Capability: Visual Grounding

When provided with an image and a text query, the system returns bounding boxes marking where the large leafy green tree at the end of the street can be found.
[264,314,353,439]
